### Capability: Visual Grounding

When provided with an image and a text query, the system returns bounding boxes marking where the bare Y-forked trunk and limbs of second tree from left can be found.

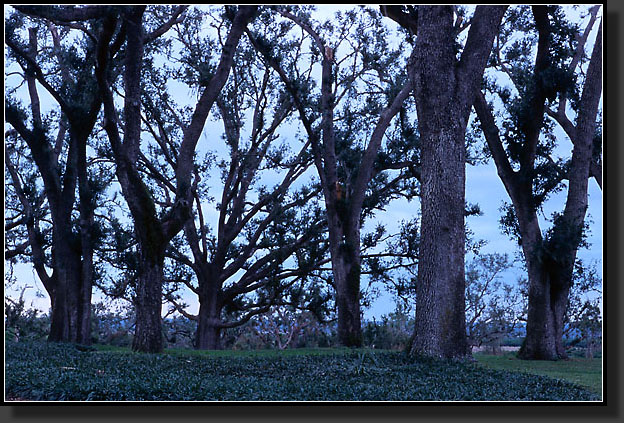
[96,6,256,352]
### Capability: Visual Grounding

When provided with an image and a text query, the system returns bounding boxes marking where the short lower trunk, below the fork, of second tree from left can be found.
[132,251,163,353]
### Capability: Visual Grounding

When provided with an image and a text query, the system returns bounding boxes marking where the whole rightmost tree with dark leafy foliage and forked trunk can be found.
[475,6,602,360]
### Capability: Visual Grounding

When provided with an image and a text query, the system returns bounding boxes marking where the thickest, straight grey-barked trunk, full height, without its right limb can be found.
[412,6,468,358]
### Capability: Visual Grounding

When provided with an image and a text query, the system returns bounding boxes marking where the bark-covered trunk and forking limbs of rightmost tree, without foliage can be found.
[474,14,602,360]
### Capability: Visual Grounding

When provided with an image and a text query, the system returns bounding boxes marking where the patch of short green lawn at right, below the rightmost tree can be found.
[474,353,602,395]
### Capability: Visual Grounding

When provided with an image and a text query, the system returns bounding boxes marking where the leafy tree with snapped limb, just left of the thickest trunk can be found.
[250,7,414,346]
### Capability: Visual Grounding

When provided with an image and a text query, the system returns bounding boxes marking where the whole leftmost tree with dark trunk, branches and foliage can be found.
[5,6,112,343]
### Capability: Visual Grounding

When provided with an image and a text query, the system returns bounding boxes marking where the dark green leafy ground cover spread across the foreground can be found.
[5,342,600,401]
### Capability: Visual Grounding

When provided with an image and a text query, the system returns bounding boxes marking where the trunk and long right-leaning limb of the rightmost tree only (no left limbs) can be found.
[519,19,602,360]
